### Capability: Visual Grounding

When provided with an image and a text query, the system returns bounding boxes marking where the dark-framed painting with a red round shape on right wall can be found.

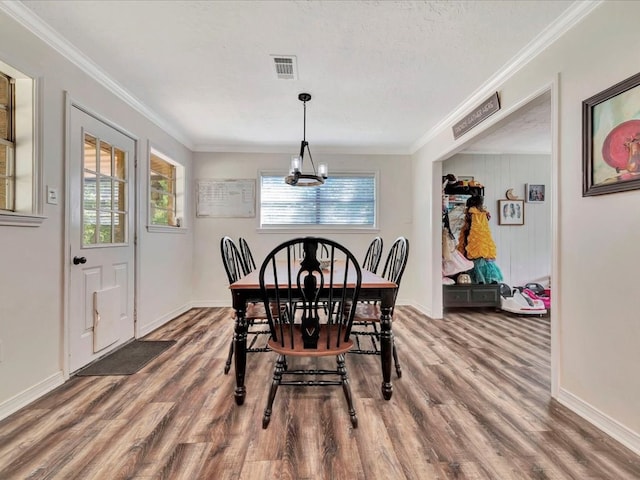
[582,73,640,197]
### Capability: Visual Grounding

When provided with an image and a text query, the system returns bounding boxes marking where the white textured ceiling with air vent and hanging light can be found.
[9,0,577,153]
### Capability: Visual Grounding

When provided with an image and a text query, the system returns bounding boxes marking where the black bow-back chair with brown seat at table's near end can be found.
[259,237,362,428]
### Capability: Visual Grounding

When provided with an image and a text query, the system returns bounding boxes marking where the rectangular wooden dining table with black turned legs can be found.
[229,267,398,405]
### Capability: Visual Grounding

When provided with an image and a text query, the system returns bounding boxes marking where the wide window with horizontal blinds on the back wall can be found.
[260,173,376,228]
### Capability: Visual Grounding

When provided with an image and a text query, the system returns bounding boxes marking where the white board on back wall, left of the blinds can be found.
[196,178,256,218]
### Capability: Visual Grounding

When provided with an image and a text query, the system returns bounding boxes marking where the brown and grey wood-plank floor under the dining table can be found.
[0,307,640,480]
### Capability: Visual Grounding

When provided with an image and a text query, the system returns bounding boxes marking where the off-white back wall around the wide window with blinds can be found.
[193,152,412,306]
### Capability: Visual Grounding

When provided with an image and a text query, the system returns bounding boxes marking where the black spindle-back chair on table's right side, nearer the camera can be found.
[351,237,409,378]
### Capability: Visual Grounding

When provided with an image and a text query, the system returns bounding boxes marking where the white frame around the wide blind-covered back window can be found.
[256,170,380,234]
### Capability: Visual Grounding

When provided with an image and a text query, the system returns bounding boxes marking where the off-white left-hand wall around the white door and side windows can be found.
[0,12,193,418]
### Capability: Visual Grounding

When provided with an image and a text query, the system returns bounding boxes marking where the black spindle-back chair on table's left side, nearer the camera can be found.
[220,236,270,375]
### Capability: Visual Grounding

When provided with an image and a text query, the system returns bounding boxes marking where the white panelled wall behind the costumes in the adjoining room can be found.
[442,154,551,287]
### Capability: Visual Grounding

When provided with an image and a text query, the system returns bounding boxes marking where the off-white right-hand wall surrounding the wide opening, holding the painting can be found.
[414,1,640,453]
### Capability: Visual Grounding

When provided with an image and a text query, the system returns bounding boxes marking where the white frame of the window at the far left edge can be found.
[0,60,47,227]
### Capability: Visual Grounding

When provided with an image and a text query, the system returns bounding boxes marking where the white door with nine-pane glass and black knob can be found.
[68,106,136,372]
